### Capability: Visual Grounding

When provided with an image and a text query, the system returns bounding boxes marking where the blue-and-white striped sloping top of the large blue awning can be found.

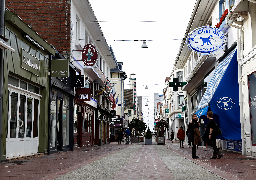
[196,49,236,116]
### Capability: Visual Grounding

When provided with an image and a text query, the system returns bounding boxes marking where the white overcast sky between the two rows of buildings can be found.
[89,0,196,96]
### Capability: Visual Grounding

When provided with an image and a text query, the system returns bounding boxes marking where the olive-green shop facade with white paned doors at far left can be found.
[1,11,55,160]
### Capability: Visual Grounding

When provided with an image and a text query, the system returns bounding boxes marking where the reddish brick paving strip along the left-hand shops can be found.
[0,143,127,180]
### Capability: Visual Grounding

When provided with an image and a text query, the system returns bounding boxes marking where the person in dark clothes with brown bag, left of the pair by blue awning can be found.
[188,114,201,159]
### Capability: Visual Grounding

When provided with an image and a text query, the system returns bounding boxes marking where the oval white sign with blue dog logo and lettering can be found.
[187,26,225,54]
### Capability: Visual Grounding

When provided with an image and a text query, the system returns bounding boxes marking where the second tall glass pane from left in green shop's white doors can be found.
[18,95,26,138]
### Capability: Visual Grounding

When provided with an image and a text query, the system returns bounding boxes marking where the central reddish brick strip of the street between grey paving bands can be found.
[114,145,173,180]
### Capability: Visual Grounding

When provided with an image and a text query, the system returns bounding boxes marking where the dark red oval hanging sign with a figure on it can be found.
[82,44,98,66]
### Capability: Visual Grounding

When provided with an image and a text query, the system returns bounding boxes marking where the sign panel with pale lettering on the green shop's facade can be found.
[21,48,40,76]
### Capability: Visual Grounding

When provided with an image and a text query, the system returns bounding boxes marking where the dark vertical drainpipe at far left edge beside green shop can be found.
[0,0,5,161]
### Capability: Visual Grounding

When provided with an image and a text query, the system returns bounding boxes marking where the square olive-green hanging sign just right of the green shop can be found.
[51,59,69,77]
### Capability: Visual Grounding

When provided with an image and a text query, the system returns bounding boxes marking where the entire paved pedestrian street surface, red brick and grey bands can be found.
[0,138,256,180]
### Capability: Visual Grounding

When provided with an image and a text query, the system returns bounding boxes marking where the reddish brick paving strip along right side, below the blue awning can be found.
[166,140,256,180]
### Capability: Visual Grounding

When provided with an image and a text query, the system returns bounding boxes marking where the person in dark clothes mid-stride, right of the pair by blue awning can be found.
[206,111,223,159]
